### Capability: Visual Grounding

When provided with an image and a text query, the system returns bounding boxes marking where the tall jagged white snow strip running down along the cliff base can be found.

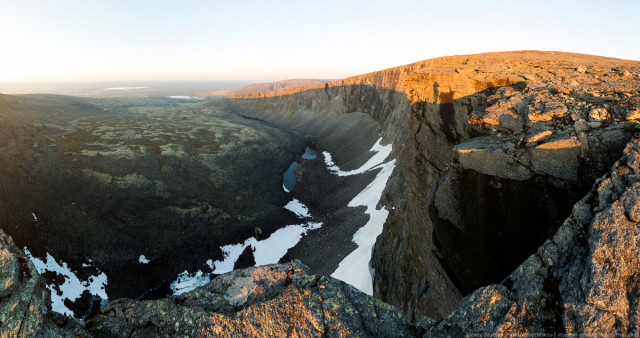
[330,138,396,295]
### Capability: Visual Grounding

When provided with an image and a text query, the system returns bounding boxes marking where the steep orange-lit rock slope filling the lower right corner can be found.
[426,139,640,336]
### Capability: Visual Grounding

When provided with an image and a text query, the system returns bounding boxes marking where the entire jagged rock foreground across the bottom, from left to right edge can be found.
[0,133,640,337]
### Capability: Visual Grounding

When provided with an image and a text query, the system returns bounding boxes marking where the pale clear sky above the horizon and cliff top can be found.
[0,0,640,82]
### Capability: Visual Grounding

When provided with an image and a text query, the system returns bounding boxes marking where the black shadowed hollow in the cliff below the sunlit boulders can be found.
[429,167,590,295]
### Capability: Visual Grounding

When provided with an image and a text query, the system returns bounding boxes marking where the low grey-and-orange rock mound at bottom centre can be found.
[87,262,410,337]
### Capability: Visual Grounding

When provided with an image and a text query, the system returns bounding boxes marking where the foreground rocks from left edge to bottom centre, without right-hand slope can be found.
[0,235,415,337]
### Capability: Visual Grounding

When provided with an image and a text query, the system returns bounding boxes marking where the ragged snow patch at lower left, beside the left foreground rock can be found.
[24,247,108,317]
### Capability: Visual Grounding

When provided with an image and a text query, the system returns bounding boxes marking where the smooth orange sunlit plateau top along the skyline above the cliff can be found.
[227,51,638,103]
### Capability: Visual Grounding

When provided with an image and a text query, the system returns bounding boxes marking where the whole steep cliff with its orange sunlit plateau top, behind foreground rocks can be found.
[232,52,640,319]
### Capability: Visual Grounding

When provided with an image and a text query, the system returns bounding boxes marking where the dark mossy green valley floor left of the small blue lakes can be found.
[0,96,304,314]
